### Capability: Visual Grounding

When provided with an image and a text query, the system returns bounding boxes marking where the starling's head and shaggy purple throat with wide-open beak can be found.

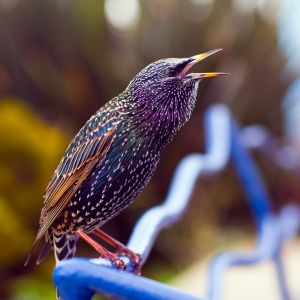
[127,49,227,135]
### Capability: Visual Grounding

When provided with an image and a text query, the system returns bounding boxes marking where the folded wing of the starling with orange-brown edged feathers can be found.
[36,115,116,240]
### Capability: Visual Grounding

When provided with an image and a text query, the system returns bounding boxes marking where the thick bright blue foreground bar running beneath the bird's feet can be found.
[54,258,201,300]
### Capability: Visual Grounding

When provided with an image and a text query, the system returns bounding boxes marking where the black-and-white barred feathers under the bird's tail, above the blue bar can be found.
[53,234,78,263]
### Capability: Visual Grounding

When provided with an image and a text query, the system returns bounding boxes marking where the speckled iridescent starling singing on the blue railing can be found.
[25,49,228,269]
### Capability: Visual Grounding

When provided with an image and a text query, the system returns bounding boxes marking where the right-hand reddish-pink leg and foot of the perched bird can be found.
[92,229,142,274]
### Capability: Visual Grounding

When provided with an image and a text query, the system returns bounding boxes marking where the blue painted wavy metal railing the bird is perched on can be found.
[54,105,300,300]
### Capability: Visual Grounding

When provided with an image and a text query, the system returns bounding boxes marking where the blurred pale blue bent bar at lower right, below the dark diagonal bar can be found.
[208,205,300,300]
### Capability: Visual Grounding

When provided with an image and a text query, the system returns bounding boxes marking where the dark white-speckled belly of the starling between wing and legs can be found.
[70,138,160,230]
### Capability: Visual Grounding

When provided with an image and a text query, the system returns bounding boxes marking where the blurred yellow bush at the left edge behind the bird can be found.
[0,98,67,299]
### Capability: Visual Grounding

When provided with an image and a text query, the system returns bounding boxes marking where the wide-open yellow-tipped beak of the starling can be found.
[179,48,229,79]
